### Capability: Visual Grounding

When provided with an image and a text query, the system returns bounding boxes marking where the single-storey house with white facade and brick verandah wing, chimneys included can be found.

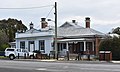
[16,17,105,56]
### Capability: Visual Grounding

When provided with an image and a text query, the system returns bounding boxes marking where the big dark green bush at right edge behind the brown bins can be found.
[99,37,120,60]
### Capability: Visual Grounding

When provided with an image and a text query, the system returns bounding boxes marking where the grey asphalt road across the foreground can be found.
[0,60,120,72]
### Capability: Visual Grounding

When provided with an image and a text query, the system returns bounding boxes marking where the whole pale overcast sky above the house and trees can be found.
[0,0,120,33]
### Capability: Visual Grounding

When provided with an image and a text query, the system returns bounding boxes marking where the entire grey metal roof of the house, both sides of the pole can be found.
[16,22,105,38]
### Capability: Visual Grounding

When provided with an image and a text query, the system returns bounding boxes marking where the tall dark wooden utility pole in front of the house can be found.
[55,2,58,59]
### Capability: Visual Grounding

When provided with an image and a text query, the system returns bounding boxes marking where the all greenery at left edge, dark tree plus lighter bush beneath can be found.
[0,18,27,51]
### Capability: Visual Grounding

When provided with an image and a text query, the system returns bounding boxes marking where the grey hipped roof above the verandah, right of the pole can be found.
[58,22,105,37]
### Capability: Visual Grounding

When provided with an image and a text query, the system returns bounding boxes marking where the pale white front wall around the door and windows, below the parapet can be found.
[16,36,53,54]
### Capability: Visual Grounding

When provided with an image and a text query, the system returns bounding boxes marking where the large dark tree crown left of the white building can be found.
[0,18,27,42]
